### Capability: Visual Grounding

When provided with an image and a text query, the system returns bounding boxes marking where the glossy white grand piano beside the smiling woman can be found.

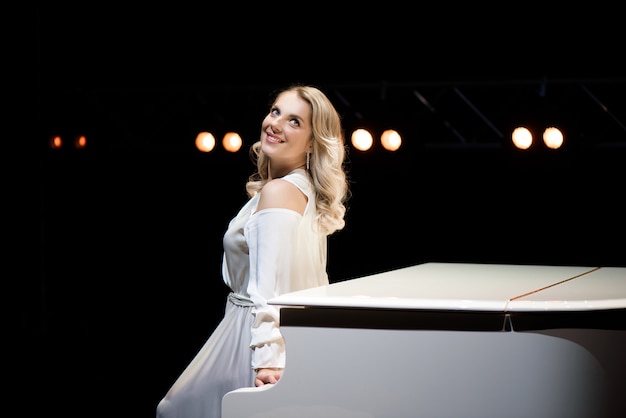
[222,263,626,418]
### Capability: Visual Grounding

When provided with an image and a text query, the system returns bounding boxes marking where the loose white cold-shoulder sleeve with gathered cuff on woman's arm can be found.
[244,208,302,369]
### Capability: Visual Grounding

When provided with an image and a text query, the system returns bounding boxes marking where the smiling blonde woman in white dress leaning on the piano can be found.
[157,86,349,418]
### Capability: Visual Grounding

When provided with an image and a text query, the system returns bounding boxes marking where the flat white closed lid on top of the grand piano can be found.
[269,262,626,312]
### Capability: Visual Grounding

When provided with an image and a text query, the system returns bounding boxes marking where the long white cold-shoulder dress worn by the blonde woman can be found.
[156,169,328,418]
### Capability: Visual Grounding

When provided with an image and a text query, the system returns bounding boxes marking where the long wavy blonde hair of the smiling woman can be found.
[246,85,350,234]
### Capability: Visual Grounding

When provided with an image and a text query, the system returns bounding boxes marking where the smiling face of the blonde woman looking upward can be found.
[261,91,312,168]
